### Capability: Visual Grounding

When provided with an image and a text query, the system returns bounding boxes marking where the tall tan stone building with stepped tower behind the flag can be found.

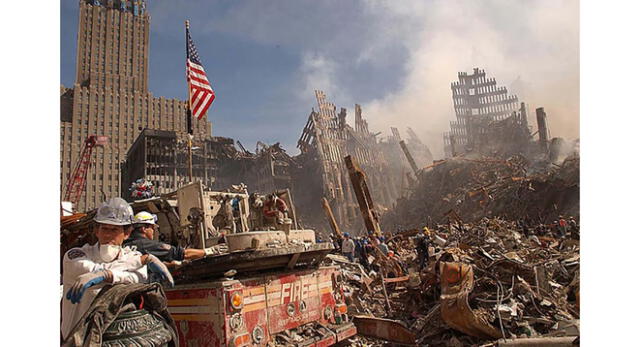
[60,0,211,210]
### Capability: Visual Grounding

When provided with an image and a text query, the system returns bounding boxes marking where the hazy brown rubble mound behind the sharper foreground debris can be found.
[381,154,580,230]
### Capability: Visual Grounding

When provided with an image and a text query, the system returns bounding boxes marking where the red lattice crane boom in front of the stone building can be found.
[64,135,109,205]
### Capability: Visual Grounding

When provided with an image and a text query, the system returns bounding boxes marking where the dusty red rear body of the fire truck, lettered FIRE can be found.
[166,267,356,346]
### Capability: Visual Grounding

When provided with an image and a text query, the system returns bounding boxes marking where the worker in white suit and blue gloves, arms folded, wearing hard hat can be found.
[61,198,173,339]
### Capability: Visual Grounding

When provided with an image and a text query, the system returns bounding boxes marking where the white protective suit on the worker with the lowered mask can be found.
[61,242,147,339]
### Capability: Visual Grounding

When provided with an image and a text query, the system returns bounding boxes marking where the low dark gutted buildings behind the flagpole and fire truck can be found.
[120,129,293,197]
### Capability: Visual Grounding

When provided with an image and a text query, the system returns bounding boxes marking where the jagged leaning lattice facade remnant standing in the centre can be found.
[293,91,416,235]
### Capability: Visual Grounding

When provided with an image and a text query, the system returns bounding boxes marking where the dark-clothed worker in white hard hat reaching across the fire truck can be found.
[124,211,218,264]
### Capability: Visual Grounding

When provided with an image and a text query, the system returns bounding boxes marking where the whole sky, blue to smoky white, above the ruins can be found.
[60,0,580,156]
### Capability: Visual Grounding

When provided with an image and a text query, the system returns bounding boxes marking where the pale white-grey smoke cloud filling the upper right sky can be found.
[363,0,580,158]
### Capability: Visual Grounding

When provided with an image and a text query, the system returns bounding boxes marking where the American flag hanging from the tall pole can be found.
[187,26,216,119]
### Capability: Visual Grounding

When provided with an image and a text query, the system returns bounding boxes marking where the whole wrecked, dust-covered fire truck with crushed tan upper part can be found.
[61,182,357,347]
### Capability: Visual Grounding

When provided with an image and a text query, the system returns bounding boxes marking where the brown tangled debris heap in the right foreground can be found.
[329,218,580,346]
